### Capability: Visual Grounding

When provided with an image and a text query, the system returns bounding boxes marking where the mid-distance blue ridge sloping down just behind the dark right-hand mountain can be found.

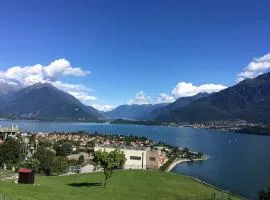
[147,93,209,119]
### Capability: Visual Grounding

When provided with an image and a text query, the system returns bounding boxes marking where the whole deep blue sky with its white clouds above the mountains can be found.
[0,0,270,110]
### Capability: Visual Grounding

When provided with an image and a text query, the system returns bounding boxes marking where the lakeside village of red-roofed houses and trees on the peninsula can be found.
[0,126,203,180]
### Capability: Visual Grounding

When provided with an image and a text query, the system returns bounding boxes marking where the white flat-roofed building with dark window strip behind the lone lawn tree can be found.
[94,146,146,169]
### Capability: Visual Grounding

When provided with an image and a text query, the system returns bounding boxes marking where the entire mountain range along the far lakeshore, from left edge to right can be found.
[0,73,270,122]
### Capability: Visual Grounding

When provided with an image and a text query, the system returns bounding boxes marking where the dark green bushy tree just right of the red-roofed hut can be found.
[33,147,55,175]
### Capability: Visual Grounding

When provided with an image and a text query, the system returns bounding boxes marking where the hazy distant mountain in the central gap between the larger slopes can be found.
[103,103,168,120]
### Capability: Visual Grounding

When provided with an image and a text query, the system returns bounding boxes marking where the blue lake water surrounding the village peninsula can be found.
[0,120,270,199]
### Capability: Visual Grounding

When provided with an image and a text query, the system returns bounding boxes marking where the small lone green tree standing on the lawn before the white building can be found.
[93,150,125,187]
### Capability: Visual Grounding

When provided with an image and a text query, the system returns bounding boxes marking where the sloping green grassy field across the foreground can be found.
[0,170,240,200]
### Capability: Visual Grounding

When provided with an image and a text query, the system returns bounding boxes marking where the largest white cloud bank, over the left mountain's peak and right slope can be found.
[0,58,97,105]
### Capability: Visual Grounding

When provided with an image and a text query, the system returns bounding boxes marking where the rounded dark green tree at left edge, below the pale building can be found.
[0,137,22,167]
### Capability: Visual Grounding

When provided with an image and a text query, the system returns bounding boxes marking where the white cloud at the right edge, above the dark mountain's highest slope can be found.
[236,53,270,82]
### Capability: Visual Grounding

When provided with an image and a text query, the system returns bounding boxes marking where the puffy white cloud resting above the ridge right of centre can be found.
[172,82,227,98]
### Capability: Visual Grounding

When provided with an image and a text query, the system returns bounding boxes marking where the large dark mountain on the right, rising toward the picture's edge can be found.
[156,73,270,122]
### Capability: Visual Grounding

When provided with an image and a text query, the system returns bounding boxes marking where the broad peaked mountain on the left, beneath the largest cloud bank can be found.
[0,83,101,120]
